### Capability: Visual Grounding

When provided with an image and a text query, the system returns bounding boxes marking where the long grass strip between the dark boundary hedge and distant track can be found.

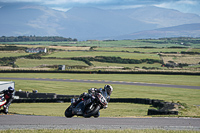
[0,73,200,86]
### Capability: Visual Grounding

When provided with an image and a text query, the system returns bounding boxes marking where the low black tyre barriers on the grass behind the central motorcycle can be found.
[13,92,178,115]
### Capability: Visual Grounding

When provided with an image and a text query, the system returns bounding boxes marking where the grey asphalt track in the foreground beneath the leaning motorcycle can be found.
[0,115,200,130]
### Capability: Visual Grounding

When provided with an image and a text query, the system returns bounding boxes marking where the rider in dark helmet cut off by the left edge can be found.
[0,86,15,114]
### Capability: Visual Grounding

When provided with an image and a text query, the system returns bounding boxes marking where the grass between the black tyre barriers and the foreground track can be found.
[9,103,150,117]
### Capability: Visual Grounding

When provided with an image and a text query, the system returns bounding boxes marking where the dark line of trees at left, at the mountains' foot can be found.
[0,35,78,42]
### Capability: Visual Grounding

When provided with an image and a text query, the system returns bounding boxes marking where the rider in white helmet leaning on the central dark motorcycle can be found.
[72,85,113,109]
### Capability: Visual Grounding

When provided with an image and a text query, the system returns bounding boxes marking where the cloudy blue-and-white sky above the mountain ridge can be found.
[0,0,200,15]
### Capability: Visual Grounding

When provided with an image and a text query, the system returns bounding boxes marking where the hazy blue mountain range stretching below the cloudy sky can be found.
[0,2,200,40]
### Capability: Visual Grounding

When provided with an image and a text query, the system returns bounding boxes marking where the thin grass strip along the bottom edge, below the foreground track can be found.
[0,129,199,133]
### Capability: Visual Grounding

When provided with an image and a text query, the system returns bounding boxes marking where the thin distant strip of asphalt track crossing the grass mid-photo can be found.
[0,77,200,89]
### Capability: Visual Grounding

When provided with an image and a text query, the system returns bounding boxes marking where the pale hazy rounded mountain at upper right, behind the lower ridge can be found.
[110,6,200,28]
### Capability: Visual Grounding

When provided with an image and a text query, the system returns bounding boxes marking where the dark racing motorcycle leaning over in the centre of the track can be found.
[65,93,108,118]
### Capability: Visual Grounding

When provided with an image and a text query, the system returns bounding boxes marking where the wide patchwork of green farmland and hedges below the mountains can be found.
[0,38,200,73]
